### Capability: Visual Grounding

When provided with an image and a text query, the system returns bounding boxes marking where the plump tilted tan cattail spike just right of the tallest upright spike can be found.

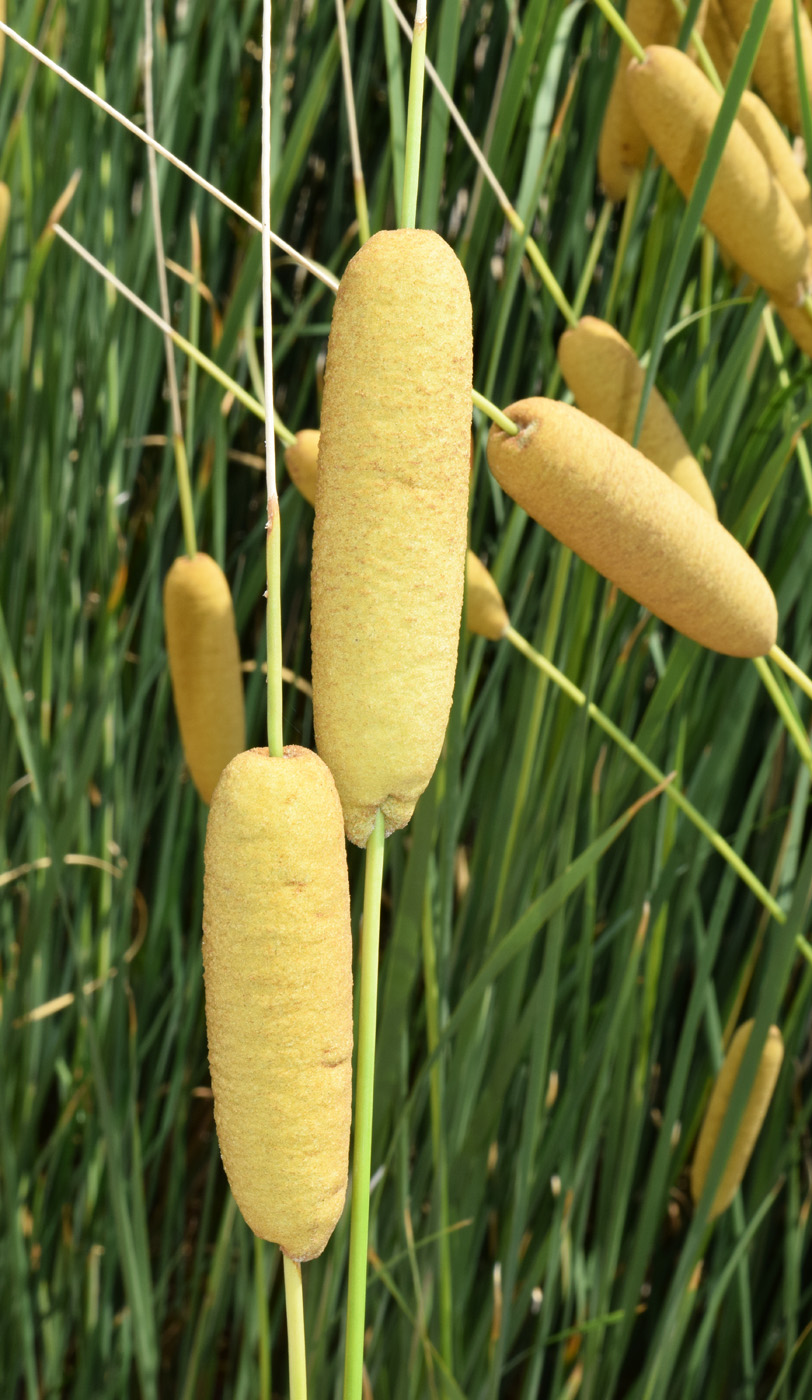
[487,399,777,657]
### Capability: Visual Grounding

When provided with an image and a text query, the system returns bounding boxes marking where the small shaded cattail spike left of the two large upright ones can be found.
[164,554,245,802]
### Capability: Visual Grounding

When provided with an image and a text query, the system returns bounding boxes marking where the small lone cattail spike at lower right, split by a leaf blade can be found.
[690,1021,784,1219]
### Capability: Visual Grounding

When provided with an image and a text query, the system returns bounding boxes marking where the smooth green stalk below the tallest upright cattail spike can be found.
[344,812,384,1400]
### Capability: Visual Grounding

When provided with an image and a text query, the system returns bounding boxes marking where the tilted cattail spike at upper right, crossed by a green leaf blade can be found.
[626,48,812,305]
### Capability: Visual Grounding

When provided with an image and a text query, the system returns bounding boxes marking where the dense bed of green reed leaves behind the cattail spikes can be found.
[0,0,812,1400]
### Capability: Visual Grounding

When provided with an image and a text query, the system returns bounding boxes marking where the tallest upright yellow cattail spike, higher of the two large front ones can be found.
[312,230,472,846]
